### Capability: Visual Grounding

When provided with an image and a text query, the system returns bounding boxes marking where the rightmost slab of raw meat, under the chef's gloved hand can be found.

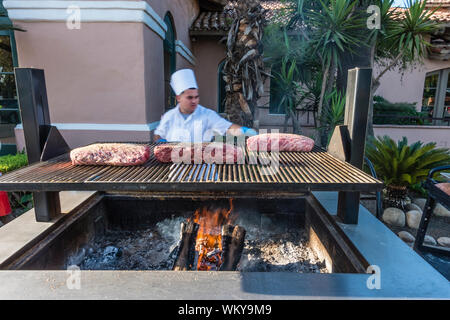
[247,133,314,152]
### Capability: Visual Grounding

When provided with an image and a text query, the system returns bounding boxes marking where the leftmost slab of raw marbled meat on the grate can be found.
[70,143,150,166]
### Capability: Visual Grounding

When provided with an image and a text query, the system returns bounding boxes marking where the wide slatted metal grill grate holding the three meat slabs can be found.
[0,144,383,192]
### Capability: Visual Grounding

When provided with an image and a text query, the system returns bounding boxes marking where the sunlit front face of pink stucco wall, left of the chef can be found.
[15,22,145,123]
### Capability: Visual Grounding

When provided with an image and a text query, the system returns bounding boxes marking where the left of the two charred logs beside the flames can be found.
[173,221,199,271]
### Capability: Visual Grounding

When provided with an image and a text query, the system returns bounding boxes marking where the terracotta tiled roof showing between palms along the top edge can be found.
[191,0,450,33]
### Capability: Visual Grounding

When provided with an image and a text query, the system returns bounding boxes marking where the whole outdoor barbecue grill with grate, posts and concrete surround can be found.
[0,68,448,299]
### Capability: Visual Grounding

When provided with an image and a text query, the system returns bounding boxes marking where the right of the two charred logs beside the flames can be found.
[219,225,246,271]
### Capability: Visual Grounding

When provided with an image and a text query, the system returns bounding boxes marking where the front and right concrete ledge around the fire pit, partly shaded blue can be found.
[0,192,450,300]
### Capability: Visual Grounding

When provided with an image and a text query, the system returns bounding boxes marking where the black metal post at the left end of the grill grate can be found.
[14,68,61,222]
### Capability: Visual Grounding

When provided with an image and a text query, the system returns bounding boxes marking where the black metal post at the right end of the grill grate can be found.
[337,68,372,224]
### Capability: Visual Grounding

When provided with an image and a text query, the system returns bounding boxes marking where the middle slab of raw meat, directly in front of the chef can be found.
[153,142,244,164]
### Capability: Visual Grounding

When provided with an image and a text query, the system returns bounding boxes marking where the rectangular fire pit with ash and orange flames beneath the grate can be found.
[2,193,368,273]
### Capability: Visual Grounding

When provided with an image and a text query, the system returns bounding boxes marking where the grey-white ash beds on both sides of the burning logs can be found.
[68,217,327,273]
